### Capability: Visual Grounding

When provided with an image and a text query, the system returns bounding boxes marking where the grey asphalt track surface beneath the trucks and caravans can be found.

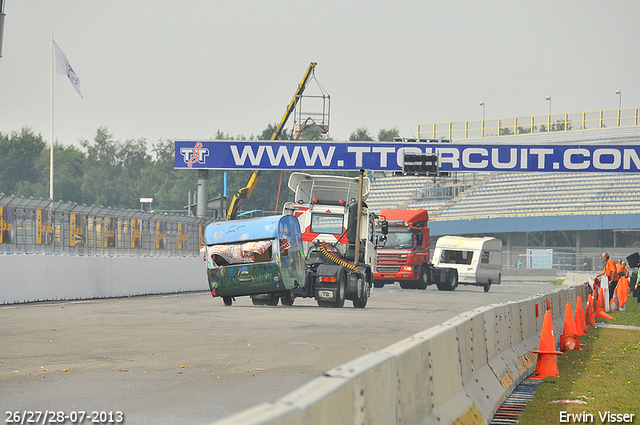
[0,282,553,425]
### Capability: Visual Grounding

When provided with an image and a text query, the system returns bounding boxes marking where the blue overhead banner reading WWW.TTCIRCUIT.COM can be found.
[174,140,640,173]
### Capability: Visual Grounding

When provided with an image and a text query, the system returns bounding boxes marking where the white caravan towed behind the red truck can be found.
[432,236,502,292]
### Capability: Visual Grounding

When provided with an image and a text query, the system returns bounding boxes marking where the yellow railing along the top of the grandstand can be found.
[418,108,640,139]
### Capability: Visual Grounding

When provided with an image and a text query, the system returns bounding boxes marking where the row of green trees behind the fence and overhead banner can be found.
[0,124,399,212]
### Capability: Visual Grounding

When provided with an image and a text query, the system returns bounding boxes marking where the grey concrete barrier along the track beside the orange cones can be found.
[214,285,587,425]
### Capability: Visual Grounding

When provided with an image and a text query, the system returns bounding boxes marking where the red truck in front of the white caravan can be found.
[373,208,458,291]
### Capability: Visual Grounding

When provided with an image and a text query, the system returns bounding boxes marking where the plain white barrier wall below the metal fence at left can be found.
[0,255,209,304]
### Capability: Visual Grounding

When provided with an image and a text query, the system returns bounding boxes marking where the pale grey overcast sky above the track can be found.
[0,0,640,150]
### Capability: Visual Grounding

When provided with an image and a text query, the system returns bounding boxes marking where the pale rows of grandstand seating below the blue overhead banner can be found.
[368,173,640,219]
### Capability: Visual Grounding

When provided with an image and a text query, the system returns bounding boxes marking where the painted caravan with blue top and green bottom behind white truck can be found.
[204,215,305,305]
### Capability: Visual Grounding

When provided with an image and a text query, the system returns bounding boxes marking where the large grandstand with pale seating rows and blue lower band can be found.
[367,121,640,271]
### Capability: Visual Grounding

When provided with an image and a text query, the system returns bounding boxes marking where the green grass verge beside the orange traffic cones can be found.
[518,294,640,425]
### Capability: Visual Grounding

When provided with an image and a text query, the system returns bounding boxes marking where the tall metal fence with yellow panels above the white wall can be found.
[0,194,212,257]
